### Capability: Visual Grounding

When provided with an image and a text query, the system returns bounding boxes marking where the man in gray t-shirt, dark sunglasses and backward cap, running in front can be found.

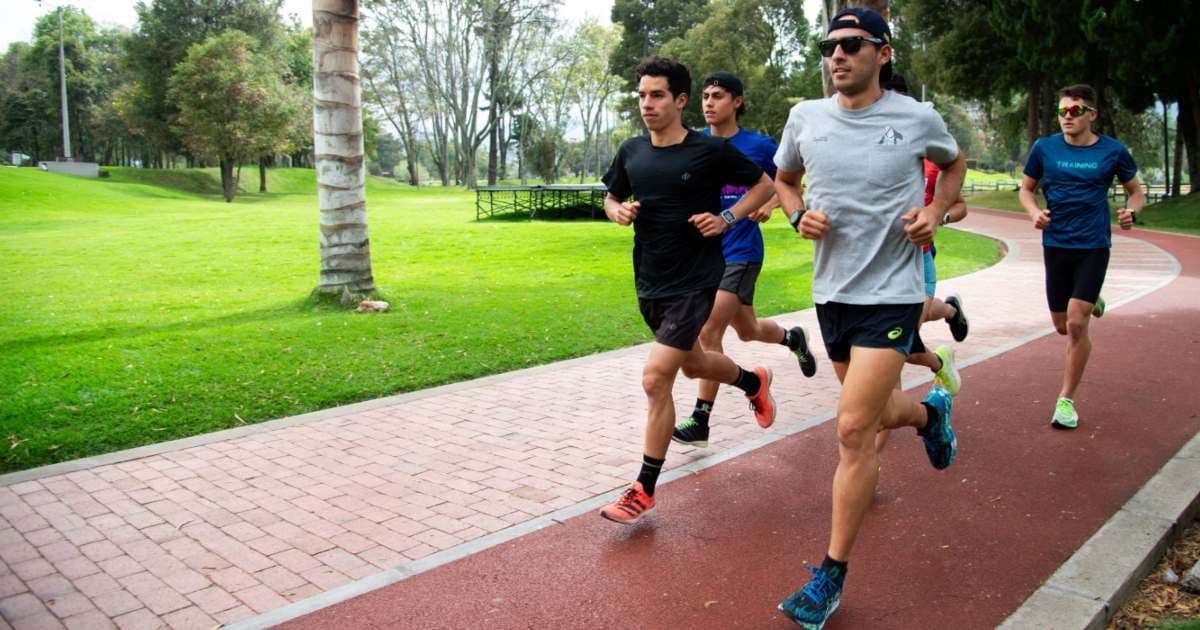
[775,8,966,629]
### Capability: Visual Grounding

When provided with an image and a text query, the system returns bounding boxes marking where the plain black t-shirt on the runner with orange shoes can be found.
[604,130,762,299]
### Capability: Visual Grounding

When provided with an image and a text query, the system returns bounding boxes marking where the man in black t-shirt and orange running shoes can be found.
[600,58,775,524]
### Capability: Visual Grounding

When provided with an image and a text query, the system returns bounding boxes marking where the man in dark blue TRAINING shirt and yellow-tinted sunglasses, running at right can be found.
[1020,85,1146,428]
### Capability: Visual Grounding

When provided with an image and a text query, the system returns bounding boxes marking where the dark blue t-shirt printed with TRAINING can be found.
[1025,133,1138,250]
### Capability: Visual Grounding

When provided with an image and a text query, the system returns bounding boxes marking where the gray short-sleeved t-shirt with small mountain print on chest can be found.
[775,91,959,305]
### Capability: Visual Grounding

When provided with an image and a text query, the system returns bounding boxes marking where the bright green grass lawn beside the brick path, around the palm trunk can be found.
[0,168,998,470]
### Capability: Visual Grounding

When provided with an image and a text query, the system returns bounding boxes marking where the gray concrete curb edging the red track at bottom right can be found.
[998,433,1200,630]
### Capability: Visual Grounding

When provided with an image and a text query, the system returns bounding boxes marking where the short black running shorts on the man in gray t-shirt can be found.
[817,302,925,364]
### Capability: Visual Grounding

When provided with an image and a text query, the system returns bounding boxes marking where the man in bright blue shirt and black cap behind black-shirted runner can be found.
[671,72,817,448]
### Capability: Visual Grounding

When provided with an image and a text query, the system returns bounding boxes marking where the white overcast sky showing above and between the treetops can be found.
[0,0,821,50]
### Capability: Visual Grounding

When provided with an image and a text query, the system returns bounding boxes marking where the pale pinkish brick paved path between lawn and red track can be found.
[0,212,1176,629]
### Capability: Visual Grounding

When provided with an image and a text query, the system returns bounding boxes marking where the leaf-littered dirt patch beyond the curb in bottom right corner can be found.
[1109,520,1200,630]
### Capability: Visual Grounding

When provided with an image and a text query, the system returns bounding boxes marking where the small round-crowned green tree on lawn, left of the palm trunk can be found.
[168,30,300,202]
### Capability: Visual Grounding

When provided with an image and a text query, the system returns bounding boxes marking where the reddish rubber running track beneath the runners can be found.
[286,225,1200,630]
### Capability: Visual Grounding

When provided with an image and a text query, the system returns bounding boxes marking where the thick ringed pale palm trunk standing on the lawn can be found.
[312,0,374,294]
